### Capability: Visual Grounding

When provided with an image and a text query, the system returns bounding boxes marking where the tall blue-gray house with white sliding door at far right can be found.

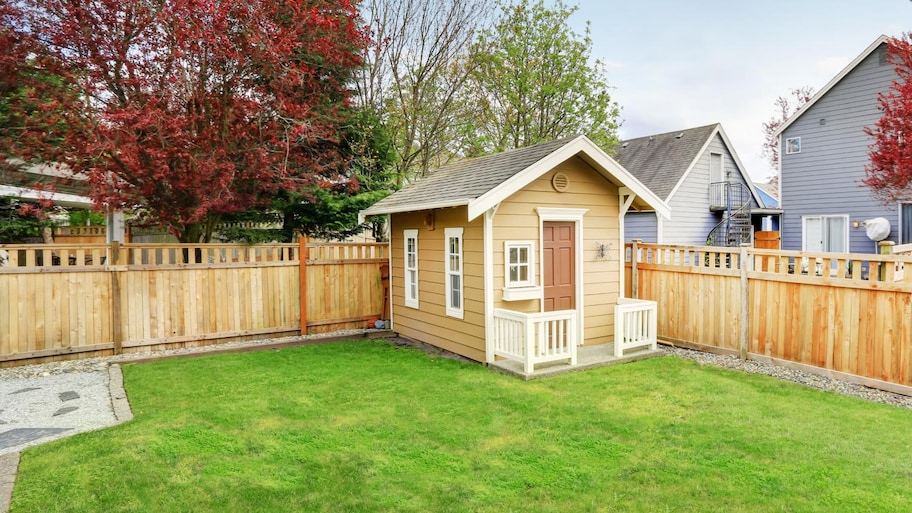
[776,36,900,253]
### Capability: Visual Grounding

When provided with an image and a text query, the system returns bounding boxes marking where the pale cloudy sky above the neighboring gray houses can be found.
[565,0,912,181]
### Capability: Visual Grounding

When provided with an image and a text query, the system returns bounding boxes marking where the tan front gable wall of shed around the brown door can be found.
[496,158,621,345]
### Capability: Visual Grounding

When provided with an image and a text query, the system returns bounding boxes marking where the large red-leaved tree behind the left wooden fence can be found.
[3,0,365,242]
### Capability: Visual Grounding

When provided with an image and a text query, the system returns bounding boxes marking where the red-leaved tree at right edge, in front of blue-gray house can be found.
[862,34,912,203]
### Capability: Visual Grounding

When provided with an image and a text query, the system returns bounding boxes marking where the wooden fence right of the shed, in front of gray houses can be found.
[625,243,912,395]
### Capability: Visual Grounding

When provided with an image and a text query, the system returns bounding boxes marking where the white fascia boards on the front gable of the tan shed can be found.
[469,135,671,221]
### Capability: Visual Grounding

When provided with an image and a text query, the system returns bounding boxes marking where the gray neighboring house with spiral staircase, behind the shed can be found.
[615,123,779,246]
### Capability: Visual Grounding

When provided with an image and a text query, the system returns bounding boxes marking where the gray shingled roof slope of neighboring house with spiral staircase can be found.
[614,123,719,201]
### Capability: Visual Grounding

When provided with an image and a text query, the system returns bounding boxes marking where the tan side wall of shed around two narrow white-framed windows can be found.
[390,207,484,361]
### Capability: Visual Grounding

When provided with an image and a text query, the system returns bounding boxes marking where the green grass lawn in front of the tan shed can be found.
[11,341,912,513]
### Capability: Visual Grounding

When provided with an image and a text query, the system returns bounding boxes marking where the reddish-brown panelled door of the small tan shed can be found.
[542,222,576,312]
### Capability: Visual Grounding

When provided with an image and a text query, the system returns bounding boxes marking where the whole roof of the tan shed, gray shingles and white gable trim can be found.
[361,136,671,221]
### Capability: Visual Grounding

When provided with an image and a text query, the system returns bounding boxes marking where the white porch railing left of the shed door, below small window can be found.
[494,308,579,374]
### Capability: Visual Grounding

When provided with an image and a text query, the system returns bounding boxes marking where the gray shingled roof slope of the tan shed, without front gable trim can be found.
[364,137,575,215]
